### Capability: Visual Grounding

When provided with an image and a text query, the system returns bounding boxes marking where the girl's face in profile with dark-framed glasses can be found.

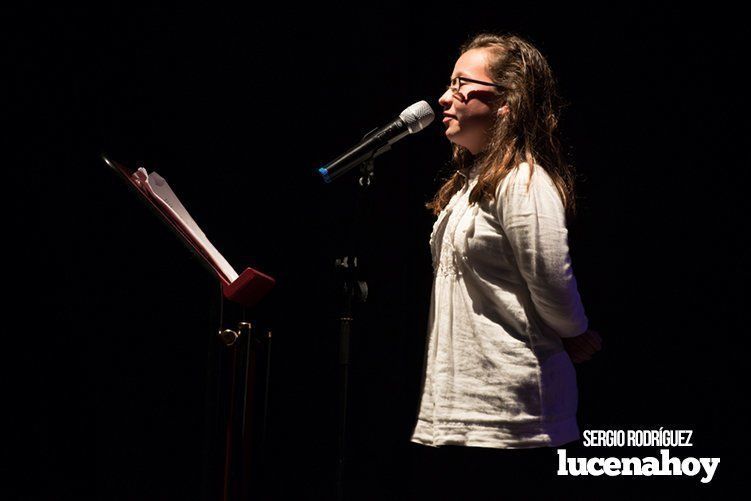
[438,49,507,155]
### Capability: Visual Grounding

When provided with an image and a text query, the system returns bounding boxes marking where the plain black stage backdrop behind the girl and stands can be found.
[2,4,748,499]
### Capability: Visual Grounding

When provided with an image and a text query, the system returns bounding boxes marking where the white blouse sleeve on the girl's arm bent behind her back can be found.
[495,162,589,337]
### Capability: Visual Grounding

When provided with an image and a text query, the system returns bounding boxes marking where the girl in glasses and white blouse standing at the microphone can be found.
[411,34,601,494]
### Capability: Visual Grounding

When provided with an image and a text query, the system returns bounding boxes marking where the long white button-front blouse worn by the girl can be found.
[410,162,588,449]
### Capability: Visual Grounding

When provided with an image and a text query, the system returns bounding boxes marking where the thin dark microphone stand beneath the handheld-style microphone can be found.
[334,129,378,501]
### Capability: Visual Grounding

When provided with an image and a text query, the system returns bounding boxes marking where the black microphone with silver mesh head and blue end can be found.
[318,101,435,183]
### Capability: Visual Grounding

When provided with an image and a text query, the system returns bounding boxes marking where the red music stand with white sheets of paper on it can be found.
[102,157,275,501]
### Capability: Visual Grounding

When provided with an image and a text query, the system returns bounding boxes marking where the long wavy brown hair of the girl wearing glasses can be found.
[426,33,576,219]
